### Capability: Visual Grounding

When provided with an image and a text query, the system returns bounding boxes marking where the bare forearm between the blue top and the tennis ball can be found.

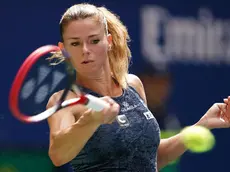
[157,134,187,169]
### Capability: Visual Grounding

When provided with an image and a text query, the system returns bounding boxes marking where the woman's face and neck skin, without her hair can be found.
[60,19,122,96]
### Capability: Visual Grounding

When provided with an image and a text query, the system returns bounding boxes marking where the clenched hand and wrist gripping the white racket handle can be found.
[77,96,120,125]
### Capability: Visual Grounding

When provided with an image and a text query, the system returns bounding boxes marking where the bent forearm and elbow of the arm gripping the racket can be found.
[49,119,99,166]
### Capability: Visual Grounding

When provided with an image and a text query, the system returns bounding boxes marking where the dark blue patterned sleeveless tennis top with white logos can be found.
[70,86,160,172]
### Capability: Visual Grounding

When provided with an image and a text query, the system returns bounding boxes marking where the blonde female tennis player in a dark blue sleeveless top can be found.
[47,4,230,172]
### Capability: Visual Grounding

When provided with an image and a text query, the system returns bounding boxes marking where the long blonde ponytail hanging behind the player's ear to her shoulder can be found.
[98,7,131,88]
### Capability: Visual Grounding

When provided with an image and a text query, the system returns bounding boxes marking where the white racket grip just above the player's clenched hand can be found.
[85,94,109,111]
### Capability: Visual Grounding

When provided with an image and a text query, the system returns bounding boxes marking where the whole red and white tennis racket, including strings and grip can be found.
[9,45,108,123]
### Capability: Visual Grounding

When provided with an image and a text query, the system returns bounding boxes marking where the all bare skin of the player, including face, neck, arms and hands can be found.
[47,18,230,169]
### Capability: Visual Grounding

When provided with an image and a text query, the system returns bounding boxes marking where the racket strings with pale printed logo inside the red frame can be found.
[19,55,68,116]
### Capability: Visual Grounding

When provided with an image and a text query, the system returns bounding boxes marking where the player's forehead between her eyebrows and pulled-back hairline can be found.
[63,18,104,38]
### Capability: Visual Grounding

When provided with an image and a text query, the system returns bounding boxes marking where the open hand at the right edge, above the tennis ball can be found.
[196,96,230,129]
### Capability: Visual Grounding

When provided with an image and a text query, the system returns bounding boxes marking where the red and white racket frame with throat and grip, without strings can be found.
[9,45,109,123]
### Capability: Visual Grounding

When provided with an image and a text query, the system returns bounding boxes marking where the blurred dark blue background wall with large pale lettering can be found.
[0,0,230,172]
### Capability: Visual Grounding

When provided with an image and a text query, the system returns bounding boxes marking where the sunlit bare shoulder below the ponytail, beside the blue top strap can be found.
[127,74,147,103]
